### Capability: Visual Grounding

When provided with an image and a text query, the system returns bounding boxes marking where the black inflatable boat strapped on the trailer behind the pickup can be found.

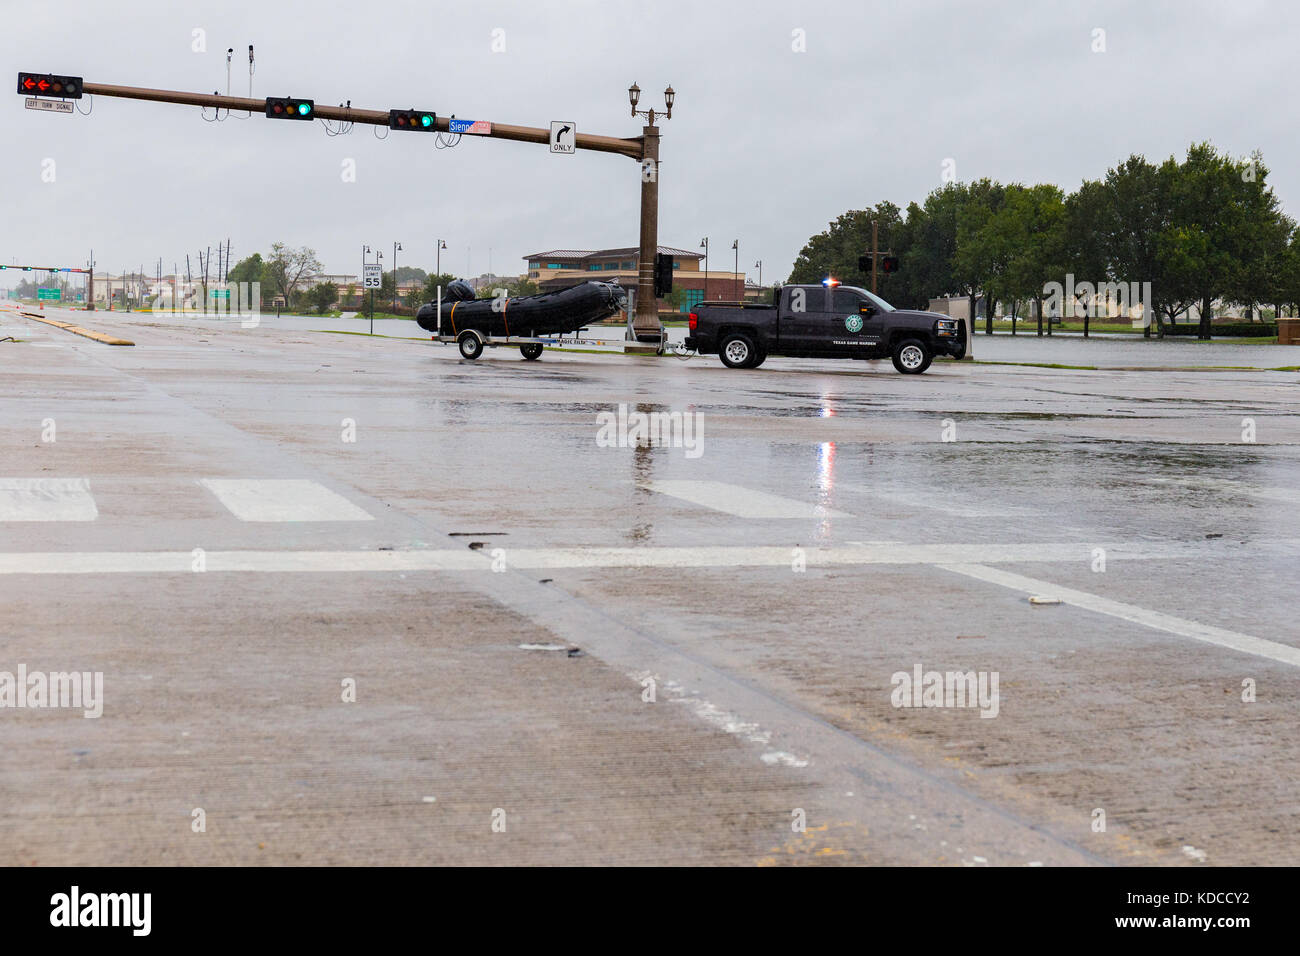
[415,282,627,338]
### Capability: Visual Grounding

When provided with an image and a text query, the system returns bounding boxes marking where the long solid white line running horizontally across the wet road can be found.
[0,544,1205,574]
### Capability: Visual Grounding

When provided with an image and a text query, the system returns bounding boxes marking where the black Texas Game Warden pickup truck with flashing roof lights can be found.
[686,285,966,375]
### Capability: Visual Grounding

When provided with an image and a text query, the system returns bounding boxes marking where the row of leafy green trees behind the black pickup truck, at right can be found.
[789,143,1300,338]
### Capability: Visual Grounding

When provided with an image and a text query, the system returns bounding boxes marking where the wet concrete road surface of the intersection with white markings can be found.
[0,306,1300,865]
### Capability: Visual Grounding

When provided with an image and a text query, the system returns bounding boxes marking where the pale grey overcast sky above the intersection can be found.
[0,0,1300,285]
